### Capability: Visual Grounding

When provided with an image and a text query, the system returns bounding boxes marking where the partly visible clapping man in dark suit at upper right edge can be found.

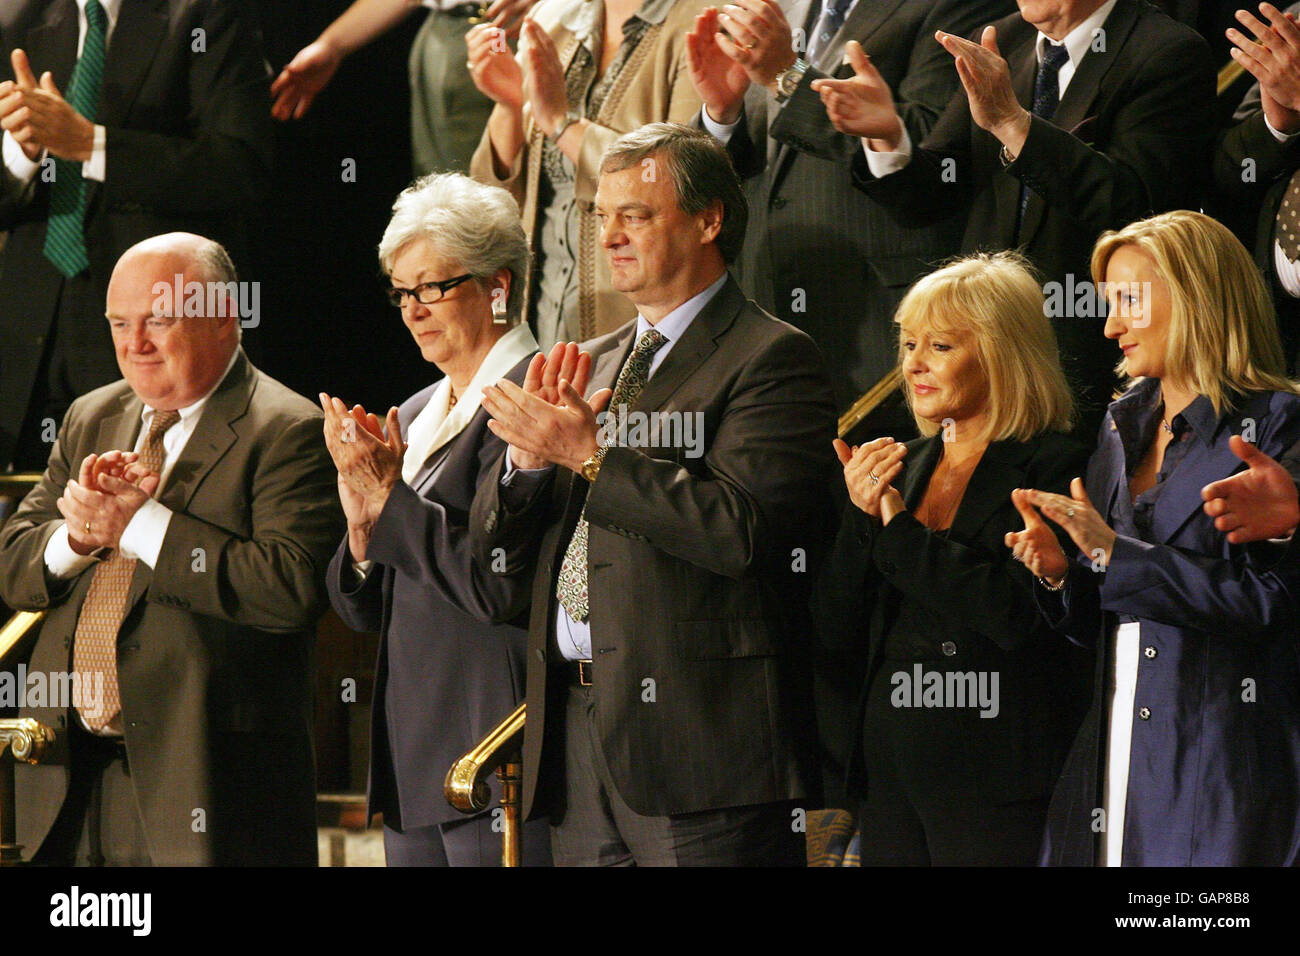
[1210,4,1300,373]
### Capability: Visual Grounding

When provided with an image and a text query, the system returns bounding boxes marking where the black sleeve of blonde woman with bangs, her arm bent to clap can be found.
[871,441,1084,650]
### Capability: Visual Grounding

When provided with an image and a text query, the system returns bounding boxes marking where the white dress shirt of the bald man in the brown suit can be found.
[46,349,239,580]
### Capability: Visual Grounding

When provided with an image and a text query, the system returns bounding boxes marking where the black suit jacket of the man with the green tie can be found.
[0,0,272,463]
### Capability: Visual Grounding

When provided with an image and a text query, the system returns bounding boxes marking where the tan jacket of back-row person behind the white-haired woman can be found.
[469,0,709,341]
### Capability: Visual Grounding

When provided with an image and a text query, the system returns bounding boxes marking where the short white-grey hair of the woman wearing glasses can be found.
[380,173,529,325]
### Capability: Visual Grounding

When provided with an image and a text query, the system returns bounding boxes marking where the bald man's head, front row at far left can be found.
[107,233,239,410]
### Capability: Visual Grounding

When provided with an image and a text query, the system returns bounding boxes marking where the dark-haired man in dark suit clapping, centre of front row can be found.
[471,124,835,865]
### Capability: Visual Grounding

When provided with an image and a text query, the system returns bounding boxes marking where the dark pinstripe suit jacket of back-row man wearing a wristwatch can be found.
[727,0,1015,411]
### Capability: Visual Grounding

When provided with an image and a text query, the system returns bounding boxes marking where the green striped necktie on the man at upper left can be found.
[46,0,108,278]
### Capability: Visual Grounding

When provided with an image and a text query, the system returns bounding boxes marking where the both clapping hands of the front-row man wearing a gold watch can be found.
[482,342,614,473]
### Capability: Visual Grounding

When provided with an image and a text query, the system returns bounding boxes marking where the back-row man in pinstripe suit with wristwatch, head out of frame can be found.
[686,0,1013,418]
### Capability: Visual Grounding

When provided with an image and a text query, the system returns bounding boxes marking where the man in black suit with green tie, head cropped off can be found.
[0,0,272,470]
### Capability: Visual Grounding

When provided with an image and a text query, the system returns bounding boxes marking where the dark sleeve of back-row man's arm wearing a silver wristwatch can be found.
[771,0,1006,165]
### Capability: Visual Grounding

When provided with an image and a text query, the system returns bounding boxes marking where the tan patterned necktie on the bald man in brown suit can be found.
[73,411,181,731]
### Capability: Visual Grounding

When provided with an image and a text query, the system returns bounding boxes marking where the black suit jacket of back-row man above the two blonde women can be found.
[853,0,1214,418]
